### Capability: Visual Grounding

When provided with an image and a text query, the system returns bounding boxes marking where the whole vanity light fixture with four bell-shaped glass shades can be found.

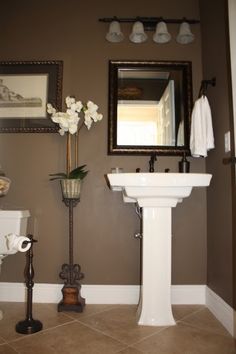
[99,16,200,44]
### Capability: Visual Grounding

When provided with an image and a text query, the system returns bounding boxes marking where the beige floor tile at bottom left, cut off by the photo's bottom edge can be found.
[11,321,124,354]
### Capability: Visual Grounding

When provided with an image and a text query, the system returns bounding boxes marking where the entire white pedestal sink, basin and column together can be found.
[107,173,212,326]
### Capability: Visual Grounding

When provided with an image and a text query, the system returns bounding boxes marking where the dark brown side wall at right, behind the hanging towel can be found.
[200,0,233,305]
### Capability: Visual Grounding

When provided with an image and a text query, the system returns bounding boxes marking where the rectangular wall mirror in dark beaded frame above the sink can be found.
[108,60,192,155]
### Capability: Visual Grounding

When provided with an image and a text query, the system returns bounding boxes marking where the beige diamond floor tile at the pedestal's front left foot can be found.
[80,305,163,345]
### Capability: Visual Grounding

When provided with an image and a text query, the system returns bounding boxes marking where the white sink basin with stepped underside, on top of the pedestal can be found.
[108,173,211,207]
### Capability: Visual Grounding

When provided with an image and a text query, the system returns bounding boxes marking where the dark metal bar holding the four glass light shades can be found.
[99,16,200,30]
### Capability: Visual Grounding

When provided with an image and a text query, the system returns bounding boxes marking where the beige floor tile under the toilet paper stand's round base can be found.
[0,302,72,341]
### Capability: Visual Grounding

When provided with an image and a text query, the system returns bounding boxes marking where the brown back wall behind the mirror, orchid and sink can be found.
[0,0,206,284]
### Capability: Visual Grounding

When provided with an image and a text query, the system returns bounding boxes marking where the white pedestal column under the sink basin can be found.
[138,203,175,326]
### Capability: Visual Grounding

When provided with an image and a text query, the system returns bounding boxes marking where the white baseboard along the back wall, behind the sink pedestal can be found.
[0,282,206,304]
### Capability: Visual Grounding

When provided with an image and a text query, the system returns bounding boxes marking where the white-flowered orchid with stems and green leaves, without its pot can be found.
[47,96,103,180]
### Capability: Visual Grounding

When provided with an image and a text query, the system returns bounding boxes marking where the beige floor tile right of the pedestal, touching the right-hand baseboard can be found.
[182,308,229,336]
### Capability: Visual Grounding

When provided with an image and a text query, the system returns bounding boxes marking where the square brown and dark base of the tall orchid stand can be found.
[57,285,85,312]
